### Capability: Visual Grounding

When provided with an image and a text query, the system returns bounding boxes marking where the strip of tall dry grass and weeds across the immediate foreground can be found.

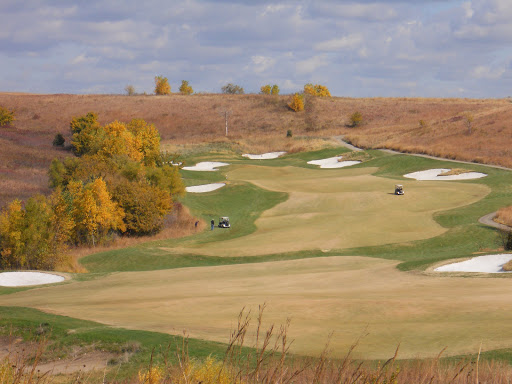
[0,305,512,384]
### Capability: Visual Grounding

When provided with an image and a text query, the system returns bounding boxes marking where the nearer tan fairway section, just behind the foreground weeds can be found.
[1,257,512,359]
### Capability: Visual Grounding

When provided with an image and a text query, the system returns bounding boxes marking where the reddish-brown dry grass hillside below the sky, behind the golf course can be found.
[0,93,512,206]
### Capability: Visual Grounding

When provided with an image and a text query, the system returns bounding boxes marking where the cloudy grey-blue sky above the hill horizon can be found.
[0,0,512,98]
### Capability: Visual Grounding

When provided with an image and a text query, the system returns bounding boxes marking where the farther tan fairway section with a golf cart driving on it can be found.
[174,165,490,256]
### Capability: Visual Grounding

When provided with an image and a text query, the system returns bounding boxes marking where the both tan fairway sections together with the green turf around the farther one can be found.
[0,149,512,359]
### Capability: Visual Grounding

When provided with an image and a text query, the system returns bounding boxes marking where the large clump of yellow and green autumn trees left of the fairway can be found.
[0,112,185,269]
